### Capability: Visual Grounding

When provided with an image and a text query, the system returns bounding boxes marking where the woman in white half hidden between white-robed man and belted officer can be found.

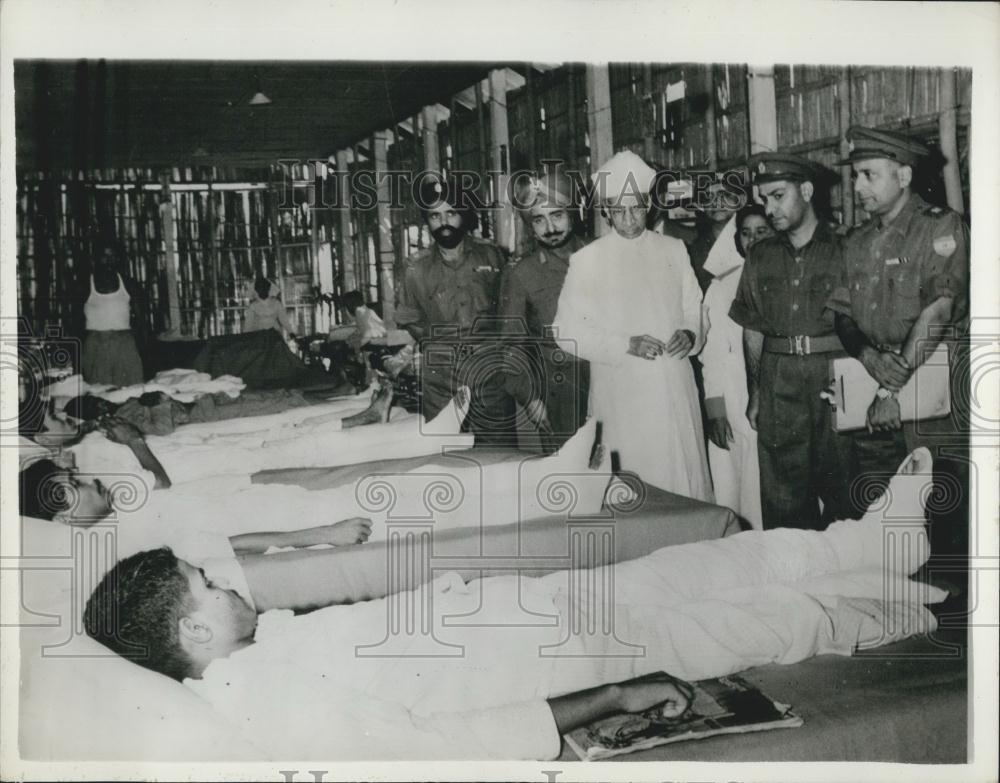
[701,204,774,529]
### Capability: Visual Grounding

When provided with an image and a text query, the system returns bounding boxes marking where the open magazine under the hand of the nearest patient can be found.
[566,677,802,761]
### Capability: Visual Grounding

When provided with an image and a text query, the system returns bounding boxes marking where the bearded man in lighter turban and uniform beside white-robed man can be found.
[500,174,590,452]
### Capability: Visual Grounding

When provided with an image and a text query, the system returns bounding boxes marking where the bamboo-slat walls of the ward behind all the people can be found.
[17,63,972,336]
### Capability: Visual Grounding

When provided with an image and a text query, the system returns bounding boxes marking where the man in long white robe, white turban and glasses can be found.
[553,152,712,501]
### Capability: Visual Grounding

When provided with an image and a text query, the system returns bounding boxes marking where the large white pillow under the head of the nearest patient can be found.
[19,518,262,761]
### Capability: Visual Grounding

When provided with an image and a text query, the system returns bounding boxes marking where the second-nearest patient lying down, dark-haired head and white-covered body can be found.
[21,420,610,557]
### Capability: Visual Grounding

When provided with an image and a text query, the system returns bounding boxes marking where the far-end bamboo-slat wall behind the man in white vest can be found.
[17,169,334,337]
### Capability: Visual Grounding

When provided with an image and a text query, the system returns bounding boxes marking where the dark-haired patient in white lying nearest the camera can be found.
[85,450,942,759]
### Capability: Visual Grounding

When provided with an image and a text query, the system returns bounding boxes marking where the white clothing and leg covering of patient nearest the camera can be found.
[187,484,944,759]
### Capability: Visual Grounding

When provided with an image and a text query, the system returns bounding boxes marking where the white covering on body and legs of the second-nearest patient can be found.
[97,421,610,558]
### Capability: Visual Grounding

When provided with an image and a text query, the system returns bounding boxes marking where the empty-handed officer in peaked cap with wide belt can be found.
[729,153,853,529]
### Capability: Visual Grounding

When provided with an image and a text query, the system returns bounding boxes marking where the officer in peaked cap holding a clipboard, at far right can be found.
[829,126,969,552]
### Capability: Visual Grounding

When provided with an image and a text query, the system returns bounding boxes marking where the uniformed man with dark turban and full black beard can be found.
[396,179,514,445]
